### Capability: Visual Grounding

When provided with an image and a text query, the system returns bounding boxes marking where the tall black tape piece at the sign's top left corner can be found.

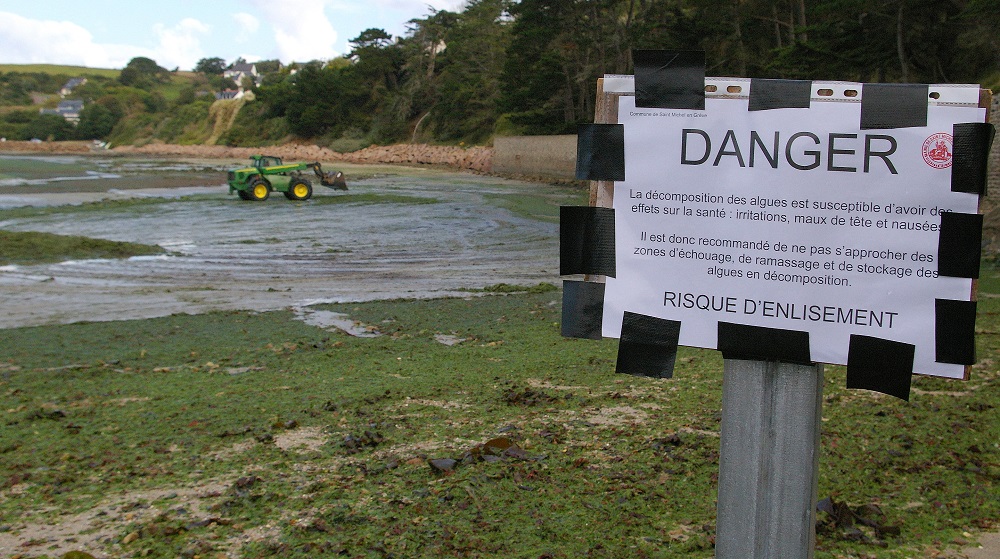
[632,50,705,110]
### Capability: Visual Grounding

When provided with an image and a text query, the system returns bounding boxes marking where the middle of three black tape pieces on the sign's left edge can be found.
[559,206,615,277]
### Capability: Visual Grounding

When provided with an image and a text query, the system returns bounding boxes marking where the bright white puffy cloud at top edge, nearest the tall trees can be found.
[251,0,339,64]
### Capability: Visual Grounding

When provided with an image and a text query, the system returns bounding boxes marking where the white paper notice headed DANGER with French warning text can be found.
[603,96,985,378]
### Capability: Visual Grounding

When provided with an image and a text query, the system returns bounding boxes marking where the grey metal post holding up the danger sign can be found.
[715,359,823,559]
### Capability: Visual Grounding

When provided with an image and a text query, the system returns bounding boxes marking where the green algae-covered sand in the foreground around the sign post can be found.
[0,282,1000,559]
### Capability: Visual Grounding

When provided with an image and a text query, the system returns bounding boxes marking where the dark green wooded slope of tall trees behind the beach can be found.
[0,0,1000,151]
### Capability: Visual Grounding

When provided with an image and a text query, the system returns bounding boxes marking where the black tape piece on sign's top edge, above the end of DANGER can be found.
[861,83,928,130]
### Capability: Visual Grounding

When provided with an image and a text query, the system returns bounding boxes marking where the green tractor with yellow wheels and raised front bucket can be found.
[228,155,347,201]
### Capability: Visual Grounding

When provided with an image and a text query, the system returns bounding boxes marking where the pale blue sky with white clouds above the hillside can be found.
[0,0,466,70]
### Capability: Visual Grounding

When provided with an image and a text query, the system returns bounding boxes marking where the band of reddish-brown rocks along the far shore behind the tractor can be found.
[0,141,493,173]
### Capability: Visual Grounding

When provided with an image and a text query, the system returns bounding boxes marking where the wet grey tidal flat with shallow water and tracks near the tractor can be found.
[0,156,579,328]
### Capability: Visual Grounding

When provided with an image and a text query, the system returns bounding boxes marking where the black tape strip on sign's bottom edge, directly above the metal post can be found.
[718,322,812,365]
